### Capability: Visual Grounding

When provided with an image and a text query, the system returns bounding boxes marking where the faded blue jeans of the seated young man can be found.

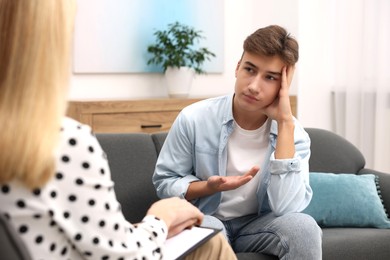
[202,213,322,260]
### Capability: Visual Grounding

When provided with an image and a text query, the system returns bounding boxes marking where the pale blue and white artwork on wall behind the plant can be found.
[73,0,224,73]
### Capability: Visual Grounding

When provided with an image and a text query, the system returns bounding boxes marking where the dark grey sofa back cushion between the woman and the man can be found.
[96,133,158,223]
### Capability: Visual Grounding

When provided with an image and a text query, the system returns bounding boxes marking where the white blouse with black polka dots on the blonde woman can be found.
[0,118,167,260]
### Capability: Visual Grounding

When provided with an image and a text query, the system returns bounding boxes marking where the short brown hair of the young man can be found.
[244,25,299,65]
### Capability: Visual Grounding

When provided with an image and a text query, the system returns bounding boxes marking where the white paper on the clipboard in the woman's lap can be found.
[164,227,221,260]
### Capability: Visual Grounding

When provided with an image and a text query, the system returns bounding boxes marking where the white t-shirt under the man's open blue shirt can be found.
[214,120,270,220]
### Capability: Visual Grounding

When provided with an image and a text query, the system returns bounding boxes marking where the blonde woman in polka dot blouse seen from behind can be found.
[0,0,236,259]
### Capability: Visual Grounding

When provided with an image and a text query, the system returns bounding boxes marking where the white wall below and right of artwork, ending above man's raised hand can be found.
[70,0,298,100]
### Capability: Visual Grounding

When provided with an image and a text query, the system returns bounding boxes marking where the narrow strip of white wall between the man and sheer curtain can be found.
[298,0,333,130]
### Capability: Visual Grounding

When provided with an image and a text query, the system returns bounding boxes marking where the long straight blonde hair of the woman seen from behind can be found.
[0,0,75,188]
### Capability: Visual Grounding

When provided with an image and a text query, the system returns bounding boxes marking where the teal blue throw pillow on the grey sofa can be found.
[303,172,390,228]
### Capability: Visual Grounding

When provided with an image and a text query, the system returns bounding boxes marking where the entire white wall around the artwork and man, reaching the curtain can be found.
[70,0,331,129]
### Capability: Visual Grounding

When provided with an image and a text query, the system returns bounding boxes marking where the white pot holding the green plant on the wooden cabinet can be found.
[165,67,195,98]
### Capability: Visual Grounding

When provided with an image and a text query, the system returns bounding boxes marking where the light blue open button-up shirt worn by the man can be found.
[153,95,312,216]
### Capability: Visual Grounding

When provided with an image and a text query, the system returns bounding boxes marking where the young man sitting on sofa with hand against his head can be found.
[153,26,322,260]
